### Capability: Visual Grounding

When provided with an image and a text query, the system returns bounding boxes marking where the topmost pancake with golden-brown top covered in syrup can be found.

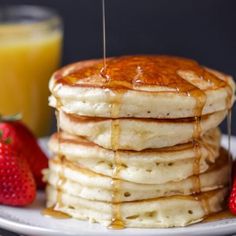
[49,55,235,118]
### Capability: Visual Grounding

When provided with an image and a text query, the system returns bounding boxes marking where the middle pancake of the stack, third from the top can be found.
[49,129,220,184]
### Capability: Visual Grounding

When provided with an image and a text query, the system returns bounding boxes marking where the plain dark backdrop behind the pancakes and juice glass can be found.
[0,0,236,135]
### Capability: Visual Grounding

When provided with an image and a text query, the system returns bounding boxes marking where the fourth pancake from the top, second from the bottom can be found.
[44,147,231,202]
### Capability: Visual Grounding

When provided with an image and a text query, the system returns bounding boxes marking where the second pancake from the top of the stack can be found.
[59,111,227,151]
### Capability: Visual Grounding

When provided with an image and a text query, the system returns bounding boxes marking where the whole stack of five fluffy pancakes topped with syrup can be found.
[45,56,235,228]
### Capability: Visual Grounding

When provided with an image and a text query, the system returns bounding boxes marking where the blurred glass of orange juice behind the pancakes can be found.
[0,5,63,136]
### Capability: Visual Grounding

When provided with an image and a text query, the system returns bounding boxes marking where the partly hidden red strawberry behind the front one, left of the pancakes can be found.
[0,116,48,189]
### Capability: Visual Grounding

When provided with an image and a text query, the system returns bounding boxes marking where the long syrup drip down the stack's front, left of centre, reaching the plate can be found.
[109,92,125,229]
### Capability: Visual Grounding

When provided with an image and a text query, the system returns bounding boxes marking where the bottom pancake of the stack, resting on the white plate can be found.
[46,185,228,228]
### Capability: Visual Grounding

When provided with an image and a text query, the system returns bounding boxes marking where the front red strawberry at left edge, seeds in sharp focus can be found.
[0,141,36,206]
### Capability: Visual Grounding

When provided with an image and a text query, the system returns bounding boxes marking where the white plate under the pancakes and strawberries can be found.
[0,136,236,236]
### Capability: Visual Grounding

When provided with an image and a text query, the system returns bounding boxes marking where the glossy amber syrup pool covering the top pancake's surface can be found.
[55,55,227,92]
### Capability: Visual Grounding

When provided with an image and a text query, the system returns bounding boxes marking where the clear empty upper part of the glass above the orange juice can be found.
[0,4,62,25]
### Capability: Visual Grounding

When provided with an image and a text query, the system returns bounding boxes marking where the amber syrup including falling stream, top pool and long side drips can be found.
[50,49,232,229]
